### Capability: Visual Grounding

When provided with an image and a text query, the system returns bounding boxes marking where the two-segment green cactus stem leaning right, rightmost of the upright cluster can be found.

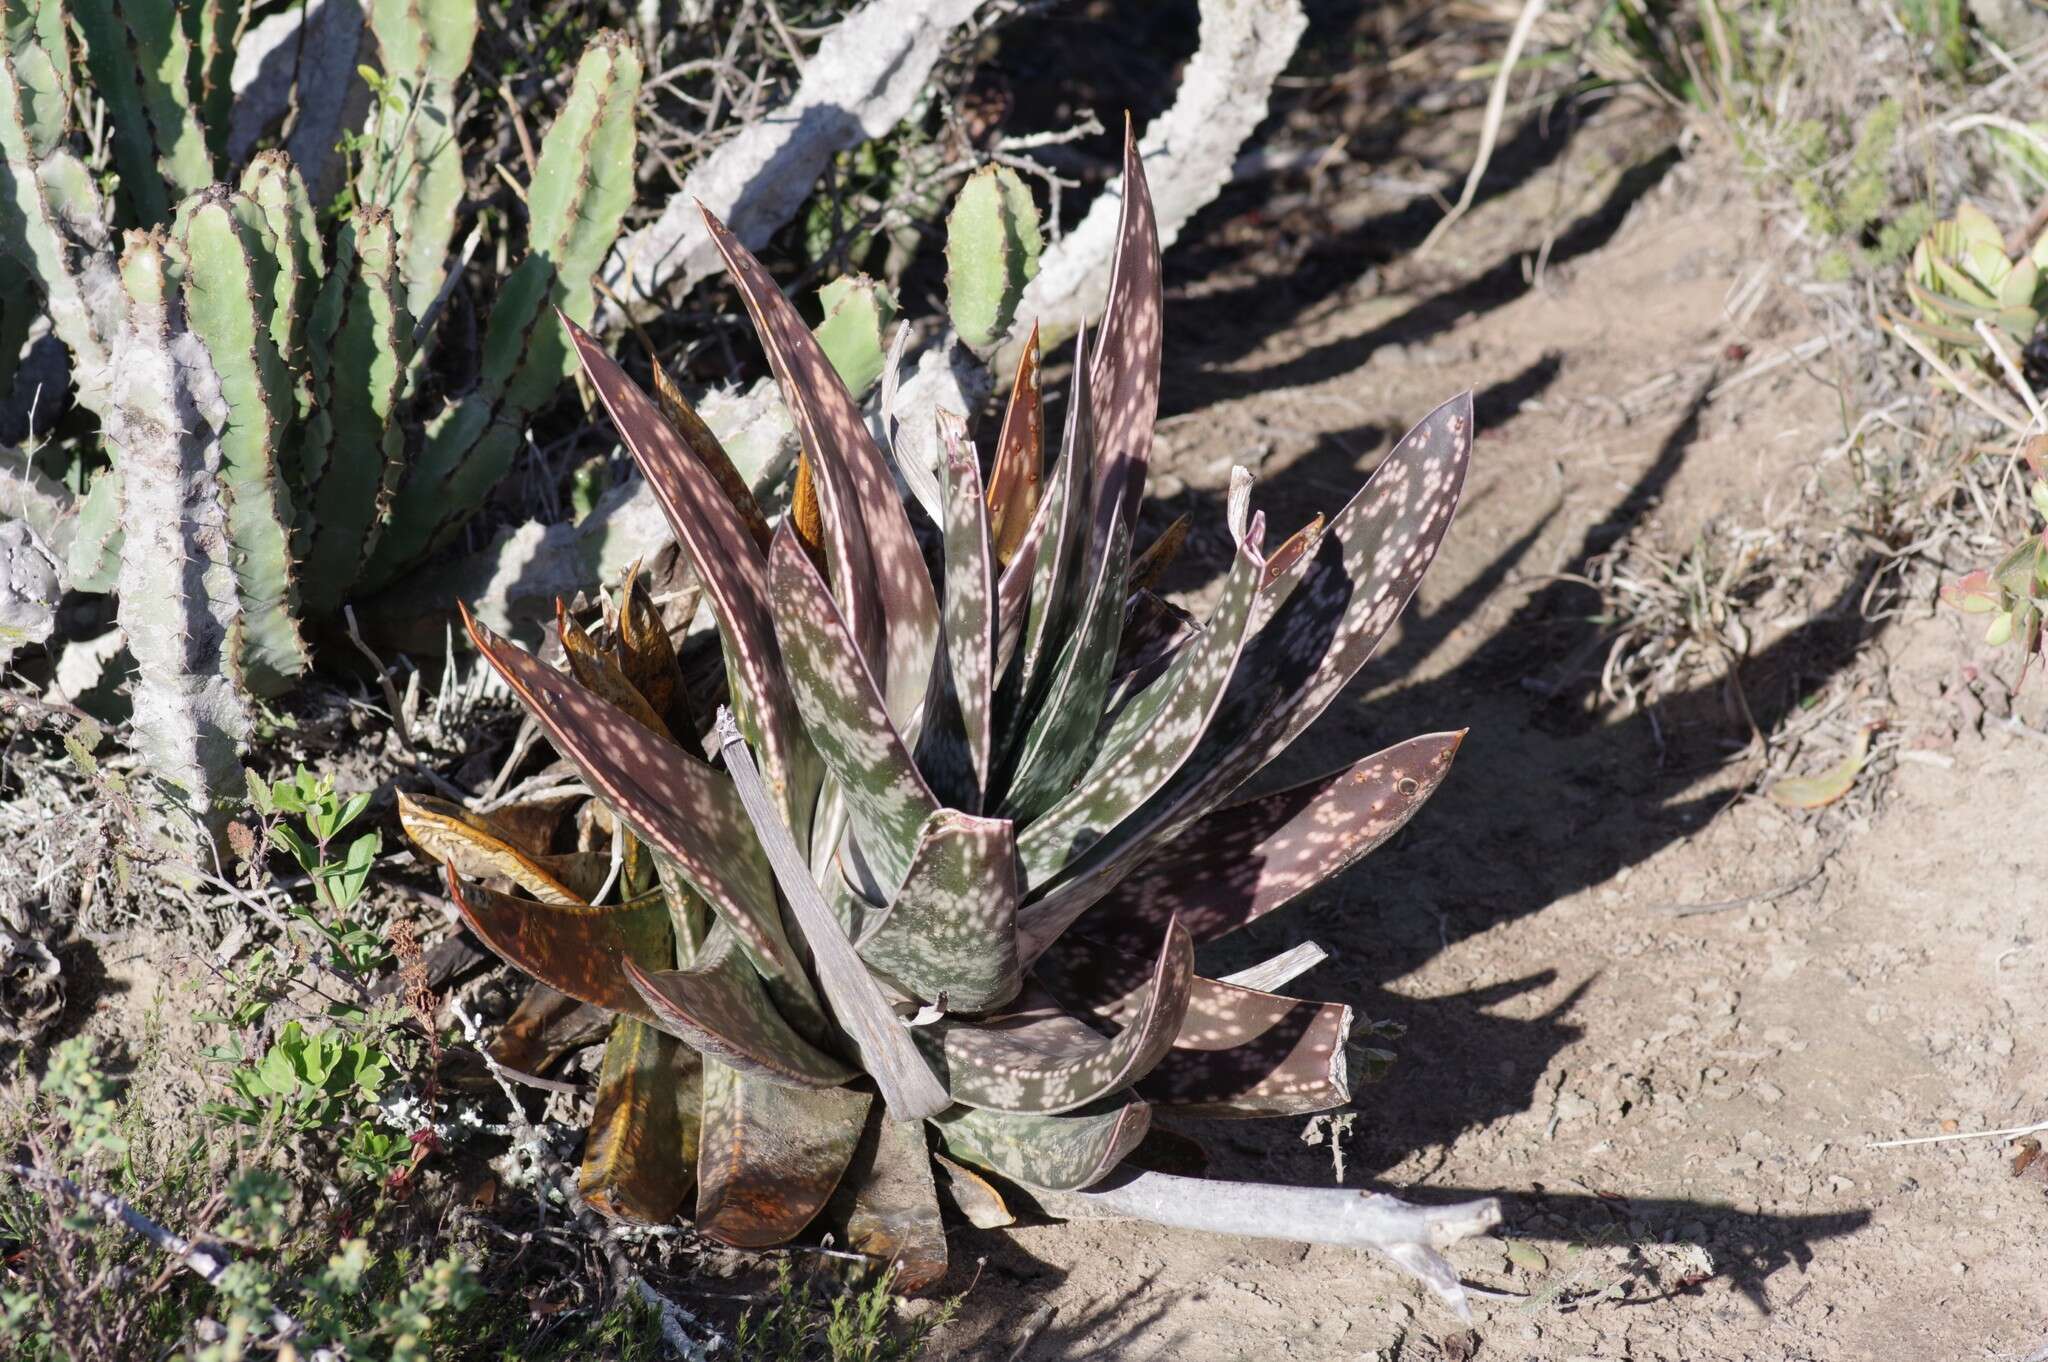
[365,33,641,588]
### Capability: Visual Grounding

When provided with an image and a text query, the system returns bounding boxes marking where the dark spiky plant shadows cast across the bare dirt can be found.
[961,114,1884,1360]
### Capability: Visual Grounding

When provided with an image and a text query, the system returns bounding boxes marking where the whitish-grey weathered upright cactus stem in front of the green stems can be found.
[104,231,250,852]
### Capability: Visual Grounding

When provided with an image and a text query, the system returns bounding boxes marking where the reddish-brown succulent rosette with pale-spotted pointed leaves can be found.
[401,143,1491,1299]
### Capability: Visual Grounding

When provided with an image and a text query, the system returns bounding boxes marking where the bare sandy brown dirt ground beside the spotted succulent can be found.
[946,102,2048,1362]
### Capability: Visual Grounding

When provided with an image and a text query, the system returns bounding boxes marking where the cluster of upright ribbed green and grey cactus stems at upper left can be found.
[0,0,641,835]
